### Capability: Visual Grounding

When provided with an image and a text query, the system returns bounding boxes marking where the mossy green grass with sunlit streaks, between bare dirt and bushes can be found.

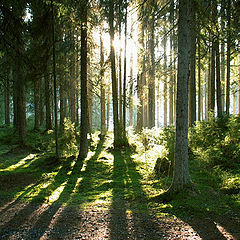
[0,124,240,220]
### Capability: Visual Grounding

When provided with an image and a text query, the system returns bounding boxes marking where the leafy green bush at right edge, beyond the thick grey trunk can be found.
[189,116,240,169]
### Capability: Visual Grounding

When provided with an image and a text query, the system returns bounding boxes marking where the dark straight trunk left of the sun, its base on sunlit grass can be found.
[78,0,89,160]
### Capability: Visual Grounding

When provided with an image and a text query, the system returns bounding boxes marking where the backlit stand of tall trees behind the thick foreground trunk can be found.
[0,0,240,169]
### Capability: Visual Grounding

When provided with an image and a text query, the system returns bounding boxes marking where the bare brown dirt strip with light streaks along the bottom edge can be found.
[0,199,240,240]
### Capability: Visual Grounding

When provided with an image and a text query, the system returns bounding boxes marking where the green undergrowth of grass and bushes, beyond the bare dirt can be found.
[0,117,240,219]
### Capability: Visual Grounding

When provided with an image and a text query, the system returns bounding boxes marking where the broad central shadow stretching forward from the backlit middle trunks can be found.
[110,151,172,240]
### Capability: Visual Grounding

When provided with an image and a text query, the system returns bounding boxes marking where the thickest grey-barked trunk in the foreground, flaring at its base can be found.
[169,0,191,192]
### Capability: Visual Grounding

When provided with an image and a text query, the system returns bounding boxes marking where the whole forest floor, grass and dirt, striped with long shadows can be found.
[0,134,240,240]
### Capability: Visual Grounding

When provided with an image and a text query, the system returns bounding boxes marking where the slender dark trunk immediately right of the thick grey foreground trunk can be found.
[189,0,196,126]
